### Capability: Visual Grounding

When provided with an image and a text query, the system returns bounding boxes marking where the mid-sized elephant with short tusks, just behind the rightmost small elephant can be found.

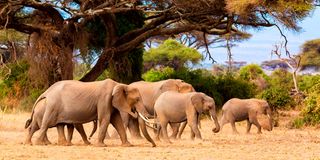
[154,91,220,142]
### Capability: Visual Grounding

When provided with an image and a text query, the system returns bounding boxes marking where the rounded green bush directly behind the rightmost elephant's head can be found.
[258,87,293,110]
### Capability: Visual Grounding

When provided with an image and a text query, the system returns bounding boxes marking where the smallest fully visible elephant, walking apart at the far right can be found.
[220,98,272,134]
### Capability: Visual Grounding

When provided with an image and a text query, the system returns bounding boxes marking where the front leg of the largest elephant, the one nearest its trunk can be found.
[110,109,132,146]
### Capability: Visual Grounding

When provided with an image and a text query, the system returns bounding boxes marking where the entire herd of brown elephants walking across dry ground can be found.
[25,79,272,147]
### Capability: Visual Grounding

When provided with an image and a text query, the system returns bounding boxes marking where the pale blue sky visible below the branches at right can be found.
[202,7,320,67]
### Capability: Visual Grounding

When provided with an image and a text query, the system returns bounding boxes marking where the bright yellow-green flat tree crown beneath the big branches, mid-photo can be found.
[143,39,202,70]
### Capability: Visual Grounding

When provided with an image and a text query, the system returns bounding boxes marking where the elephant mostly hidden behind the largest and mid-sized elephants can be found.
[107,79,195,138]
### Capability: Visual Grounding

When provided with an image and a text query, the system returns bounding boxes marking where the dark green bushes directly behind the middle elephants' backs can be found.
[143,67,255,108]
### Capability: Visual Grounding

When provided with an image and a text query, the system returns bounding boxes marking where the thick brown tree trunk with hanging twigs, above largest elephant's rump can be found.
[27,33,73,88]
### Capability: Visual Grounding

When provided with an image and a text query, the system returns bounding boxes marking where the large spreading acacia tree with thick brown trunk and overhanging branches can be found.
[0,0,317,81]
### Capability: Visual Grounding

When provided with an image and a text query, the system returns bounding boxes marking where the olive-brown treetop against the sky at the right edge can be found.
[300,39,320,69]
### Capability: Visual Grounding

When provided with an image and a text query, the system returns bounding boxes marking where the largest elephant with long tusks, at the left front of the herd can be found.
[26,79,155,146]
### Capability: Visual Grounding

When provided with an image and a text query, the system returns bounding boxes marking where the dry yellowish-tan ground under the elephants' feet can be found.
[0,113,320,160]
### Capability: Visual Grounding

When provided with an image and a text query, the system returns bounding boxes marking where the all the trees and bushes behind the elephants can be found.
[0,0,320,126]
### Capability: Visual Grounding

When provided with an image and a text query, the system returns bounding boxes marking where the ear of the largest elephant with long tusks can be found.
[112,84,135,116]
